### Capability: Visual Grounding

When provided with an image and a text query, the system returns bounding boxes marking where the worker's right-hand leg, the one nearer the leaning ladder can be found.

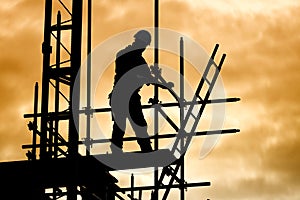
[129,93,152,152]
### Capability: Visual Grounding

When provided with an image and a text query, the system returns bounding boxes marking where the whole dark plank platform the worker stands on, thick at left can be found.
[0,149,177,199]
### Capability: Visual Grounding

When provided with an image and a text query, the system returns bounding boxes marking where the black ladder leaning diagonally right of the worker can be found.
[151,44,226,200]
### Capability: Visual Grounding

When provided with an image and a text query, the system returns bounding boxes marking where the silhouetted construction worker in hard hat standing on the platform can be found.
[110,30,154,153]
